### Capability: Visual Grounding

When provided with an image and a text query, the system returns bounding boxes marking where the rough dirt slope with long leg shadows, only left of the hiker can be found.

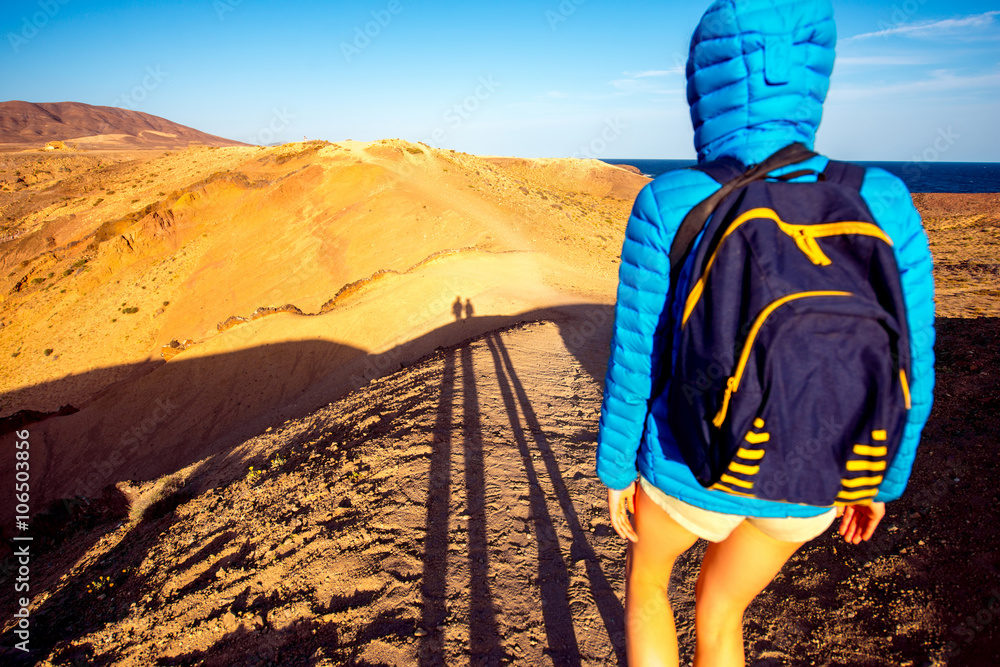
[5,323,624,665]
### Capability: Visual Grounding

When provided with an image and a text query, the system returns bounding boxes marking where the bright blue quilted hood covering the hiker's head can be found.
[687,0,837,165]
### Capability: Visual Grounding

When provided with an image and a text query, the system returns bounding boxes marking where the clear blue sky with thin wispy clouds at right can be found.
[0,0,1000,161]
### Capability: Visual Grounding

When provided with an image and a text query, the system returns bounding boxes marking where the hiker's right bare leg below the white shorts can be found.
[694,521,804,667]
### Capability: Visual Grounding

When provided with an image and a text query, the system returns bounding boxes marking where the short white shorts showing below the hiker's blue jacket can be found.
[639,476,837,542]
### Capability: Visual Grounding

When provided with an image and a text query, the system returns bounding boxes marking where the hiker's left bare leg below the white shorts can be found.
[625,487,698,667]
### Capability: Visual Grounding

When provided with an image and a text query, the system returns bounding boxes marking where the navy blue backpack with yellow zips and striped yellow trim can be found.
[667,144,910,506]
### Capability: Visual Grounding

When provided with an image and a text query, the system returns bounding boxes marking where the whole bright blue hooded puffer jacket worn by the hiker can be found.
[597,0,934,517]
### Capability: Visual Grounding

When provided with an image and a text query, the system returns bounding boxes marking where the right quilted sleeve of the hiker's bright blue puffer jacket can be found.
[861,168,934,502]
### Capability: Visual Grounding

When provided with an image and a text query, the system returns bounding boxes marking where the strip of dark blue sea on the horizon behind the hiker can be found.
[604,160,1000,192]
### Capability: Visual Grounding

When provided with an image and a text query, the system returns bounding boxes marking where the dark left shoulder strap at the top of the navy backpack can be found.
[670,143,816,286]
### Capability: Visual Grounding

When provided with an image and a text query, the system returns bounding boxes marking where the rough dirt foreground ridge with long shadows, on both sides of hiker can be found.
[0,318,1000,667]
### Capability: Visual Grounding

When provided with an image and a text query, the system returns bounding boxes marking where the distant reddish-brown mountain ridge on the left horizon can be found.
[0,100,247,148]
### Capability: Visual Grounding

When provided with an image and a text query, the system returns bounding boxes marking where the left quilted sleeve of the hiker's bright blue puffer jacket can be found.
[597,185,670,489]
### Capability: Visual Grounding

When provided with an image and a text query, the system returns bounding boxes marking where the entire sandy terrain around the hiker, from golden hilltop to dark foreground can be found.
[0,140,1000,667]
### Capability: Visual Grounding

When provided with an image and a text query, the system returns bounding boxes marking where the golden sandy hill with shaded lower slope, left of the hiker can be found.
[0,141,646,520]
